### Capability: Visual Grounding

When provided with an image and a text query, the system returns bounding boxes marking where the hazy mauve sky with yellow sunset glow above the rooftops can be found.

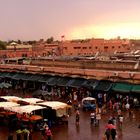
[0,0,140,40]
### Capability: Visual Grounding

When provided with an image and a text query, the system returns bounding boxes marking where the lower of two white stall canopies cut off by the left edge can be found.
[0,102,20,110]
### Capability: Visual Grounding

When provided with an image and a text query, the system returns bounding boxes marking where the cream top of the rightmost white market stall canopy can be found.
[38,101,67,110]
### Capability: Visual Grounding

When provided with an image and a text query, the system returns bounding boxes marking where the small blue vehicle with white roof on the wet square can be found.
[82,97,96,110]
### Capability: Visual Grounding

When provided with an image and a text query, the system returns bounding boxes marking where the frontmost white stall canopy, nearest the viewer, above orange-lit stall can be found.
[10,105,45,114]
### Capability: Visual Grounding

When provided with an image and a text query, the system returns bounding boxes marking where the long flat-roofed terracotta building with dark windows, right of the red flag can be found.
[61,38,133,55]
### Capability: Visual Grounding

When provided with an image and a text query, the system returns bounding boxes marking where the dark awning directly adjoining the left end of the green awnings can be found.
[95,81,113,92]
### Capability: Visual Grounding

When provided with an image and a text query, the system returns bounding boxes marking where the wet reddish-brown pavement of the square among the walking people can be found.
[0,109,140,140]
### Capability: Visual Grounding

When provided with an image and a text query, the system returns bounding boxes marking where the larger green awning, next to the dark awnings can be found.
[112,83,132,93]
